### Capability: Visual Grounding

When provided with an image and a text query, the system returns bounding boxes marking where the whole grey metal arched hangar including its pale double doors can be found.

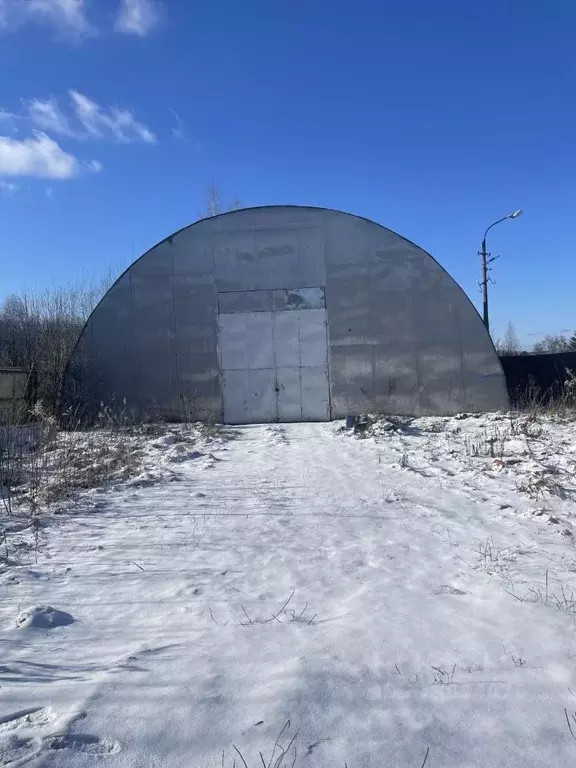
[65,206,508,424]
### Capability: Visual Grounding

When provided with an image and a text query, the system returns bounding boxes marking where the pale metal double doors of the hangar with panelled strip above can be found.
[218,288,330,424]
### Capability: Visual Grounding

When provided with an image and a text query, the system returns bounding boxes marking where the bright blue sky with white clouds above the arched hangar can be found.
[0,0,576,344]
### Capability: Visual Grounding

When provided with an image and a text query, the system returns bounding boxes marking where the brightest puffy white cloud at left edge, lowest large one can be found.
[0,131,102,183]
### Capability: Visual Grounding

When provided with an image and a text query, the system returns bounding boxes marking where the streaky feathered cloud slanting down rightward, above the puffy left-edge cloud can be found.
[70,91,156,144]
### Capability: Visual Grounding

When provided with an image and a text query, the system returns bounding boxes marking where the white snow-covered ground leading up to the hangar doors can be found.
[0,414,576,768]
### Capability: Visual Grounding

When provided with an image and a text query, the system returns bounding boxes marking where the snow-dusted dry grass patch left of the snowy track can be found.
[0,403,236,565]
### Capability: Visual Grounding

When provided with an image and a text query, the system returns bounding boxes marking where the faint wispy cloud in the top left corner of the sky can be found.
[0,0,94,36]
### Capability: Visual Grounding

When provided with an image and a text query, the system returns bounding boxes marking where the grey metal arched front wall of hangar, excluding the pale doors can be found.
[67,206,508,419]
